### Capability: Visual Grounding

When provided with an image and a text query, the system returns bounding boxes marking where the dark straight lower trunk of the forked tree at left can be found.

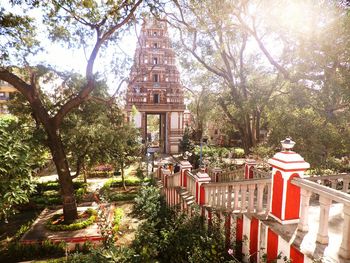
[46,127,78,224]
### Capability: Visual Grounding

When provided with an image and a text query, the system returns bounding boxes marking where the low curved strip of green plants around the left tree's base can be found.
[45,208,97,231]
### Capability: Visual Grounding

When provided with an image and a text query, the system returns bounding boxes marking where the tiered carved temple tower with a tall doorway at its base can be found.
[126,17,185,153]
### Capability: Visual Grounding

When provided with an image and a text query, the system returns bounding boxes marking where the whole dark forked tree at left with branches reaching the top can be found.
[0,0,142,223]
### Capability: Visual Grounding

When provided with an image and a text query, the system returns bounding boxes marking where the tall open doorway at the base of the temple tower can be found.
[146,113,166,153]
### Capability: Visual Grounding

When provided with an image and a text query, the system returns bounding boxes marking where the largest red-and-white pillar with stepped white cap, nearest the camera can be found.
[268,142,310,224]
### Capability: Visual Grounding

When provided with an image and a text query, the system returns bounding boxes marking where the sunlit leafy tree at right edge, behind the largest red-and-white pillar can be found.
[260,2,350,168]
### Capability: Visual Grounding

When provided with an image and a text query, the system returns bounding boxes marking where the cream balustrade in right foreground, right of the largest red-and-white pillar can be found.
[292,176,350,258]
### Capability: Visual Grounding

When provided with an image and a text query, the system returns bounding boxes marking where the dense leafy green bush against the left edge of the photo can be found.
[0,117,35,220]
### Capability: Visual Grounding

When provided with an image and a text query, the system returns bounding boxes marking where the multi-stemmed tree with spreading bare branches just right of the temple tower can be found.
[168,0,283,153]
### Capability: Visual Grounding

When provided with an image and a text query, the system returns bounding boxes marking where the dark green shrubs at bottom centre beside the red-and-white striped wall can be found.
[132,186,227,262]
